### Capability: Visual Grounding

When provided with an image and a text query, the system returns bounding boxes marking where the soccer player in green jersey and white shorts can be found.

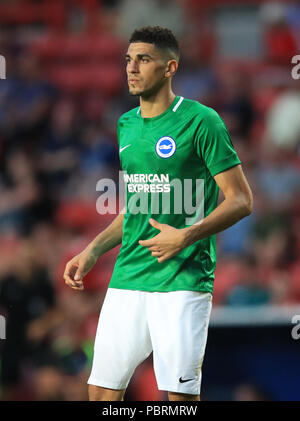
[64,27,252,401]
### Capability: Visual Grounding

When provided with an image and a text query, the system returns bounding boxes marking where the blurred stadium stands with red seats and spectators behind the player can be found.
[0,0,300,401]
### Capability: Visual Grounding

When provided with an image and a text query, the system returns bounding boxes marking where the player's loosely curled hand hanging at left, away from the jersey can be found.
[64,250,97,290]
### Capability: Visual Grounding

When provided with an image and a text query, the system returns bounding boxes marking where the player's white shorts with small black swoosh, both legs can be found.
[88,288,212,395]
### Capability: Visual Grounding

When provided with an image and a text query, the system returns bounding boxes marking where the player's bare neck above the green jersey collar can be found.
[140,90,176,118]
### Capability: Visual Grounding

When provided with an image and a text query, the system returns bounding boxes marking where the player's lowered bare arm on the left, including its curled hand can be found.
[64,208,125,290]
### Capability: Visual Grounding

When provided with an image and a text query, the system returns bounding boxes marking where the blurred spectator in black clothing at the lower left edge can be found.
[0,241,55,393]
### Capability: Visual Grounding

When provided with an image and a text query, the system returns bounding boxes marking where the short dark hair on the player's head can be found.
[129,26,180,61]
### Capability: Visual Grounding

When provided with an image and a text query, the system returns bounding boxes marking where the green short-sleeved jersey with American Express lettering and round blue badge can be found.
[109,96,241,293]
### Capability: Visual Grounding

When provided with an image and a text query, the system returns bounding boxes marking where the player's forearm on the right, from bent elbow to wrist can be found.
[184,196,252,247]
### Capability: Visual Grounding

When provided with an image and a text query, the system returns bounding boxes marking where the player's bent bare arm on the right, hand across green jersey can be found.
[139,165,253,263]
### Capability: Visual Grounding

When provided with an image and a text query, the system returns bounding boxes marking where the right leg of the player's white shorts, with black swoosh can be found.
[147,291,212,395]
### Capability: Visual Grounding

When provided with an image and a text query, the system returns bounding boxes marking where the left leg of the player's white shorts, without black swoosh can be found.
[88,288,152,390]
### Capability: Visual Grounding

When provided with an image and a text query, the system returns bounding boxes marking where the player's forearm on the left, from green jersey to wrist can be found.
[87,209,124,259]
